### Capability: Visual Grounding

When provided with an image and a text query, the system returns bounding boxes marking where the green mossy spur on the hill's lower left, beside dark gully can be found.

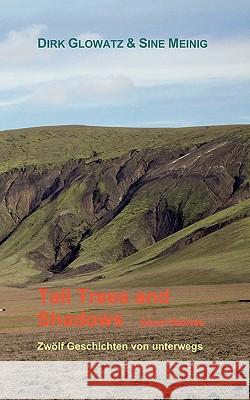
[0,183,87,285]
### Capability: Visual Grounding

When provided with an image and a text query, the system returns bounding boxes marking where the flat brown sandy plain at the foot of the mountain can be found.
[0,284,250,360]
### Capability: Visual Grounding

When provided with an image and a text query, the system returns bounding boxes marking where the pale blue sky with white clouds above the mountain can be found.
[0,0,250,130]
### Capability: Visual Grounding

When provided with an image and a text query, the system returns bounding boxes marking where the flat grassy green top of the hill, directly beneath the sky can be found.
[0,125,250,172]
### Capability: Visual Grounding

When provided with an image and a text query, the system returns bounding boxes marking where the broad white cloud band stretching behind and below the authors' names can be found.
[0,25,250,107]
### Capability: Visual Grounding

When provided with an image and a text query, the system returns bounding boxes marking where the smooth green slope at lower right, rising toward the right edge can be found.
[49,199,250,288]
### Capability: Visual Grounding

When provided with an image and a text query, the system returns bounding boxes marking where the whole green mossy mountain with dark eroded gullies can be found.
[0,125,250,287]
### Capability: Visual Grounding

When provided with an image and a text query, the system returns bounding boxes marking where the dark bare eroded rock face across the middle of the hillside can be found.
[0,134,250,276]
